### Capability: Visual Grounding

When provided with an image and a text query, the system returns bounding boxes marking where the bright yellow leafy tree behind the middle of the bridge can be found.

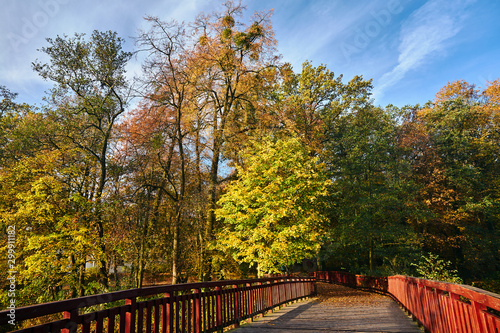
[215,137,329,277]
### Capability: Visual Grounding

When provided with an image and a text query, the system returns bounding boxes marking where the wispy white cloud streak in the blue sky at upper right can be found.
[373,0,473,99]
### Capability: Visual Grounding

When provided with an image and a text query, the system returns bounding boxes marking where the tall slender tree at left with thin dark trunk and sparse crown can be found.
[33,31,131,287]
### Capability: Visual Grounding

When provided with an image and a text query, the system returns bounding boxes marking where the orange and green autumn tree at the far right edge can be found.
[405,81,500,278]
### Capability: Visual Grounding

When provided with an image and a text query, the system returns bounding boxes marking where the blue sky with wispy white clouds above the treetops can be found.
[0,0,500,106]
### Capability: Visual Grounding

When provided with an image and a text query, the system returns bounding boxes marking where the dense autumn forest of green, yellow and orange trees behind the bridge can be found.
[0,3,500,307]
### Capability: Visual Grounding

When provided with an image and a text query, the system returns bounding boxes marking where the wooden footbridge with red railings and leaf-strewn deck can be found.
[0,272,500,333]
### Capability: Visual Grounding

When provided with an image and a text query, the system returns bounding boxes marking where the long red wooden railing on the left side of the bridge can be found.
[0,277,315,333]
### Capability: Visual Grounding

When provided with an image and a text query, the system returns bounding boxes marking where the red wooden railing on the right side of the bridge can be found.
[314,272,500,333]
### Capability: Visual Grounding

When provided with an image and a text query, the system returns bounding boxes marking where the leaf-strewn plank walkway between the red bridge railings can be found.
[231,283,423,333]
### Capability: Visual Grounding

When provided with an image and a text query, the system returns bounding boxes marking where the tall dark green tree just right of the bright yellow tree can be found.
[325,104,415,274]
